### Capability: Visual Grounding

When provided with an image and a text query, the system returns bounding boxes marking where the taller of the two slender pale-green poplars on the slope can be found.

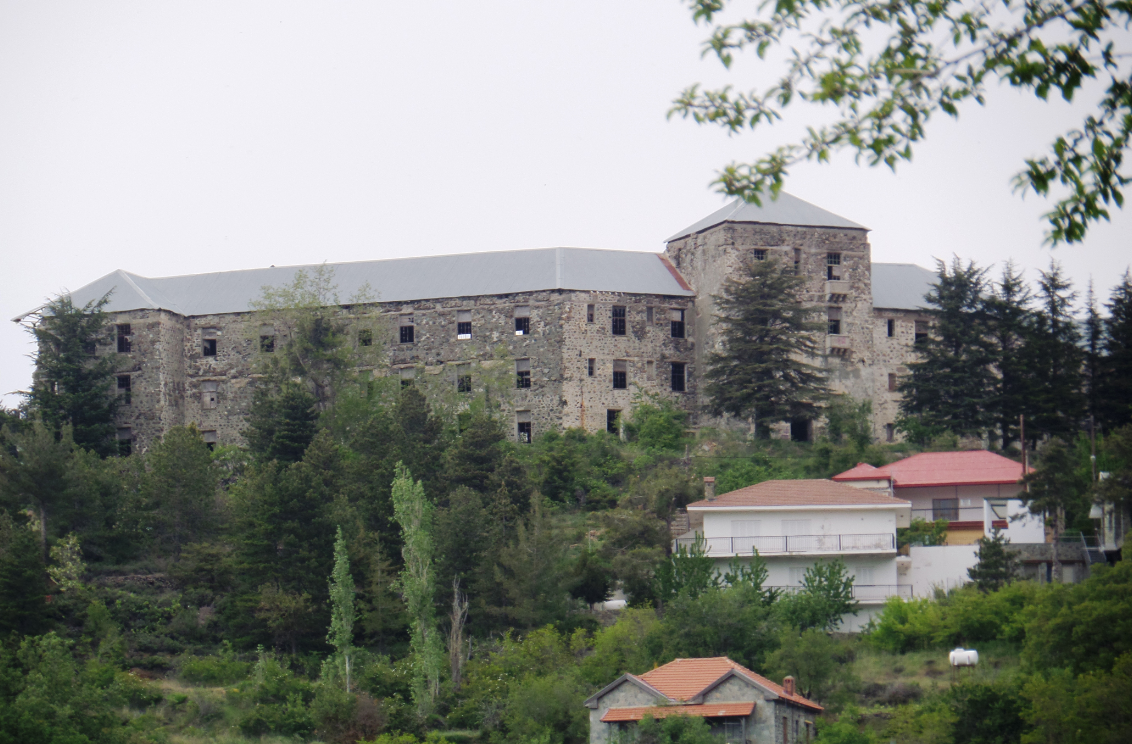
[393,462,444,719]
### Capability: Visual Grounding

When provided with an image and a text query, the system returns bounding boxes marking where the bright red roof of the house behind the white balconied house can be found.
[833,450,1022,488]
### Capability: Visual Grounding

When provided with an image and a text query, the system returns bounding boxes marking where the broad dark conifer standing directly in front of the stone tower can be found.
[704,258,827,436]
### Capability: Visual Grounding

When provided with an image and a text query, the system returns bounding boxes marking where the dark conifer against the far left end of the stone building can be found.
[27,293,119,456]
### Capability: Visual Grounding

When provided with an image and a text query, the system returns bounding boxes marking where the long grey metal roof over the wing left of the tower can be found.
[24,248,694,316]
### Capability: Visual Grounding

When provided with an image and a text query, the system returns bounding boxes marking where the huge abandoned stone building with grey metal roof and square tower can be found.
[17,194,935,447]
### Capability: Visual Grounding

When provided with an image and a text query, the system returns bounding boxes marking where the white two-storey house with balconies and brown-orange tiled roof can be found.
[676,479,911,631]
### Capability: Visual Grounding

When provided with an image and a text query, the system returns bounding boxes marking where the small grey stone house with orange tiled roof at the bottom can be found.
[585,656,822,744]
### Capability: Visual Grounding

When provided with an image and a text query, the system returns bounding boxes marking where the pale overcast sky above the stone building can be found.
[0,0,1132,405]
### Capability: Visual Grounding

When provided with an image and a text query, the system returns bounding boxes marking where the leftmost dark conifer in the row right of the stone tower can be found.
[899,257,995,436]
